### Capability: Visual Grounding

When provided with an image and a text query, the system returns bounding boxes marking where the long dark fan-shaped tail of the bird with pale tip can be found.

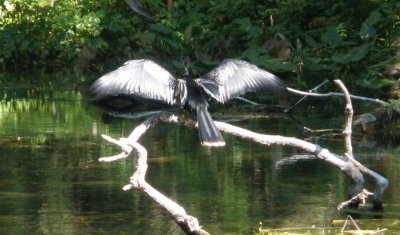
[197,107,225,146]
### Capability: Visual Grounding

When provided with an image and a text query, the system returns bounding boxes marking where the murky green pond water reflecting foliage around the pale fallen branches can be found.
[0,76,400,234]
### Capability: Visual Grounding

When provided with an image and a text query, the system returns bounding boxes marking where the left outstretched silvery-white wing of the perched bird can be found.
[91,60,180,105]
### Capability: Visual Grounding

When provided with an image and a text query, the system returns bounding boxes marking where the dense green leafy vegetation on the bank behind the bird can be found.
[0,0,400,94]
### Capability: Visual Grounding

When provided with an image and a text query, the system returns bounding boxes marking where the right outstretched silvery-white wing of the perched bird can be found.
[195,59,284,103]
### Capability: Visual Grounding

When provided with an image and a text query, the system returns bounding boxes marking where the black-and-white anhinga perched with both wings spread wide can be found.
[91,59,284,146]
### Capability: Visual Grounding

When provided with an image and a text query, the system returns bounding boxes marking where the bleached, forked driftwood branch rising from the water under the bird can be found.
[99,80,389,234]
